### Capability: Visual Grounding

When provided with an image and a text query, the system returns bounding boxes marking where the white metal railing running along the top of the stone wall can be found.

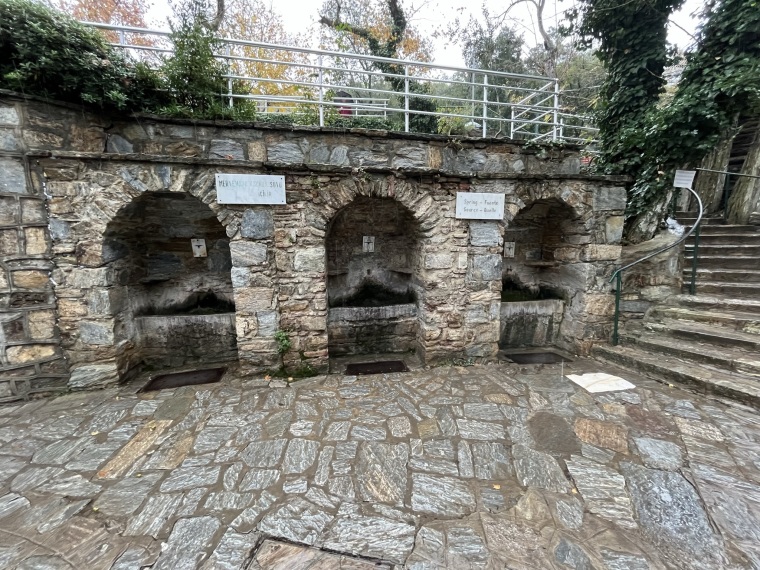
[83,22,597,144]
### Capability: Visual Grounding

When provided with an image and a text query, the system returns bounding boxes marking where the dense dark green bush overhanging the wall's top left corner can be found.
[0,0,163,110]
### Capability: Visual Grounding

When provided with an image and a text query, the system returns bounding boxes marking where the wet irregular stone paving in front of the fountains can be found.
[0,360,760,570]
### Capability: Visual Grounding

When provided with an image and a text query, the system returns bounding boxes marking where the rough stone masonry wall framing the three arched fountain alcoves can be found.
[0,92,625,401]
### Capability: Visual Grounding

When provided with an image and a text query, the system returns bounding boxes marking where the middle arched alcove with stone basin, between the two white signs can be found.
[325,196,421,356]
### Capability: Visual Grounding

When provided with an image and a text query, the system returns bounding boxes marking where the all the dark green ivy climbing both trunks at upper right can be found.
[576,0,760,242]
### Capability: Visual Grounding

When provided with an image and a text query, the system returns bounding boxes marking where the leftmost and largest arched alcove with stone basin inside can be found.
[103,192,237,374]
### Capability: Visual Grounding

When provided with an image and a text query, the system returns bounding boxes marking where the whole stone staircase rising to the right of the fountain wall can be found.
[594,213,760,409]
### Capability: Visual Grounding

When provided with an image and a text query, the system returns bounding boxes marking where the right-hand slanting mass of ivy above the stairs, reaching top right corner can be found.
[621,0,760,222]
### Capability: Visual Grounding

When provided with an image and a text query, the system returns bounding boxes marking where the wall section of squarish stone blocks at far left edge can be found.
[0,100,69,402]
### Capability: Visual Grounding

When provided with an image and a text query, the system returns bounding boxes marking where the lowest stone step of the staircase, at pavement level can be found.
[592,345,760,409]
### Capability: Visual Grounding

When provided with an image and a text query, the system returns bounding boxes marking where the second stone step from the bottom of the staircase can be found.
[620,329,760,374]
